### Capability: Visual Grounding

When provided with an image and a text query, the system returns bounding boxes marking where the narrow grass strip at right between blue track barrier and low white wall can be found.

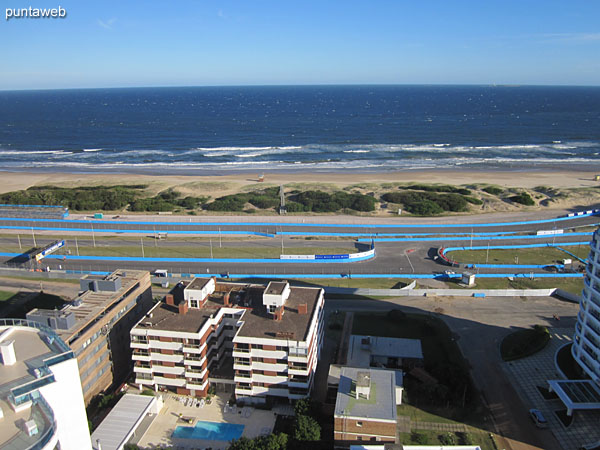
[446,275,583,295]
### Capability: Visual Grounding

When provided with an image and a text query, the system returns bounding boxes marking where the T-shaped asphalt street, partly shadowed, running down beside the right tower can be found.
[325,297,578,450]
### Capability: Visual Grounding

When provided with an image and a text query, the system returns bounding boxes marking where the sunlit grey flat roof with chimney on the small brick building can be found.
[335,367,396,421]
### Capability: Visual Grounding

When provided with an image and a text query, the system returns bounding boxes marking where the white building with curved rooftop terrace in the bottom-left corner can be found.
[0,319,92,450]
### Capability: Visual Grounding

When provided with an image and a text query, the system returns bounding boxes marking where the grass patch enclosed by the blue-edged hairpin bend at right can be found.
[446,245,590,264]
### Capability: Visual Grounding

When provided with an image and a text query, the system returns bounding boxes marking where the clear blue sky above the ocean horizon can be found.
[0,0,600,89]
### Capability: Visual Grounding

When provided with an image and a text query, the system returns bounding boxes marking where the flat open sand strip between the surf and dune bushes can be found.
[0,169,600,197]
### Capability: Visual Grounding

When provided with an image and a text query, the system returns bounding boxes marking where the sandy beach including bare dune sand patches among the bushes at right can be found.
[0,170,600,217]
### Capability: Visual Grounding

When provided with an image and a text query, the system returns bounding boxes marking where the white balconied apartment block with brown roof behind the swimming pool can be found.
[131,278,324,403]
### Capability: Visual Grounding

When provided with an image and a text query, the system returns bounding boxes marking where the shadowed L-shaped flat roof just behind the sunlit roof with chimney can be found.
[347,334,423,367]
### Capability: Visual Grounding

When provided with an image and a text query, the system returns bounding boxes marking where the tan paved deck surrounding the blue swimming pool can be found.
[137,393,275,450]
